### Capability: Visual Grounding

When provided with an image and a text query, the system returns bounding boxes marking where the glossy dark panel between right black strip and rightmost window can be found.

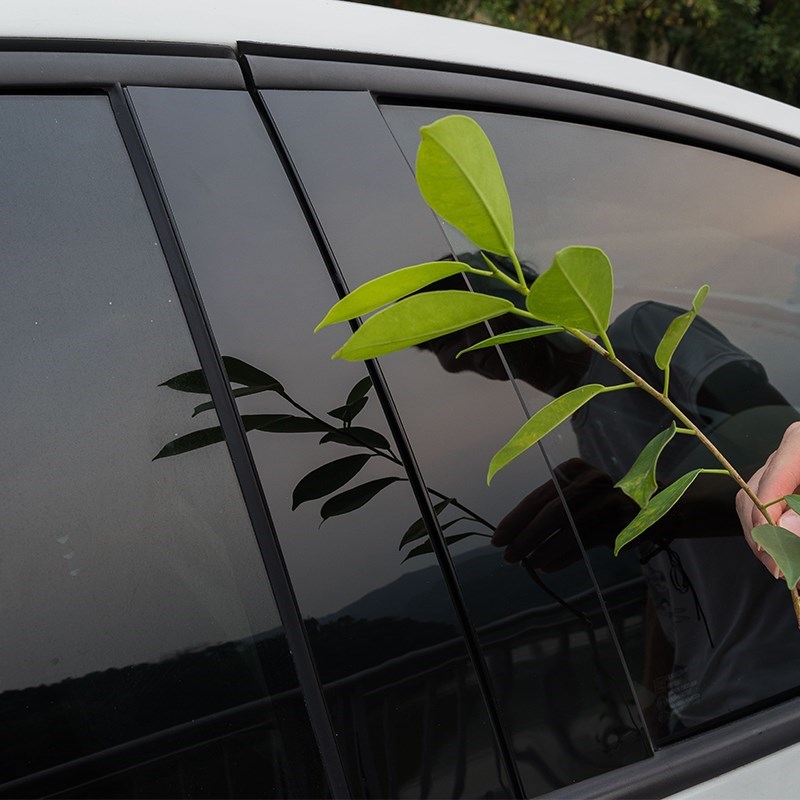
[264,92,648,795]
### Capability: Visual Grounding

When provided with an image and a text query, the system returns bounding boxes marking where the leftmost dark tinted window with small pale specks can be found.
[0,96,326,797]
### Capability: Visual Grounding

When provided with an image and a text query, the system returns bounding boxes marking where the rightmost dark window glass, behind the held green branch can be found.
[383,107,800,740]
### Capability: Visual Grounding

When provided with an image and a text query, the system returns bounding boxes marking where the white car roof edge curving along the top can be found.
[0,0,800,140]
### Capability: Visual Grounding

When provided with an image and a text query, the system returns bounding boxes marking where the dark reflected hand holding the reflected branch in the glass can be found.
[492,458,638,572]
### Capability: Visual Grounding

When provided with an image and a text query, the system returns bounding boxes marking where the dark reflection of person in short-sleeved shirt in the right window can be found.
[418,256,800,728]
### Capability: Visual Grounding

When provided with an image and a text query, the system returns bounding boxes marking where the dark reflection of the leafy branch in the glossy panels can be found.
[153,360,494,561]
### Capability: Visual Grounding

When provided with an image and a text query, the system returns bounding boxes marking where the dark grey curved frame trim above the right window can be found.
[239,48,800,174]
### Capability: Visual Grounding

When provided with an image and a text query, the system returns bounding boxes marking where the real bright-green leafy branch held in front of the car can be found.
[317,115,800,625]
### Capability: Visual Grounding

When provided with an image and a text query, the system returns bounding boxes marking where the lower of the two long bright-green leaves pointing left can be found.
[333,290,514,361]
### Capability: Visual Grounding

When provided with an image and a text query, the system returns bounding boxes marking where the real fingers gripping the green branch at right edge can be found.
[736,422,800,578]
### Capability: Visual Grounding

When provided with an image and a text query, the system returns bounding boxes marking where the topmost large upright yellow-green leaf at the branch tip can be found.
[416,114,514,256]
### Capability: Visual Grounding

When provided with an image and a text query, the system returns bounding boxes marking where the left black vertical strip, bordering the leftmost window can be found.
[109,85,350,798]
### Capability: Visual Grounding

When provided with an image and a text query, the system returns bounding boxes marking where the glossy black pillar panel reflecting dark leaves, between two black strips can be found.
[131,89,509,797]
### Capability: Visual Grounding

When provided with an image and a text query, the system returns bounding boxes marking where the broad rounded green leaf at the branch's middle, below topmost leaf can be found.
[526,247,614,334]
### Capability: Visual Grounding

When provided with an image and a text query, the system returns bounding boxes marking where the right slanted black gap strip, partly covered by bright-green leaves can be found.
[242,69,525,797]
